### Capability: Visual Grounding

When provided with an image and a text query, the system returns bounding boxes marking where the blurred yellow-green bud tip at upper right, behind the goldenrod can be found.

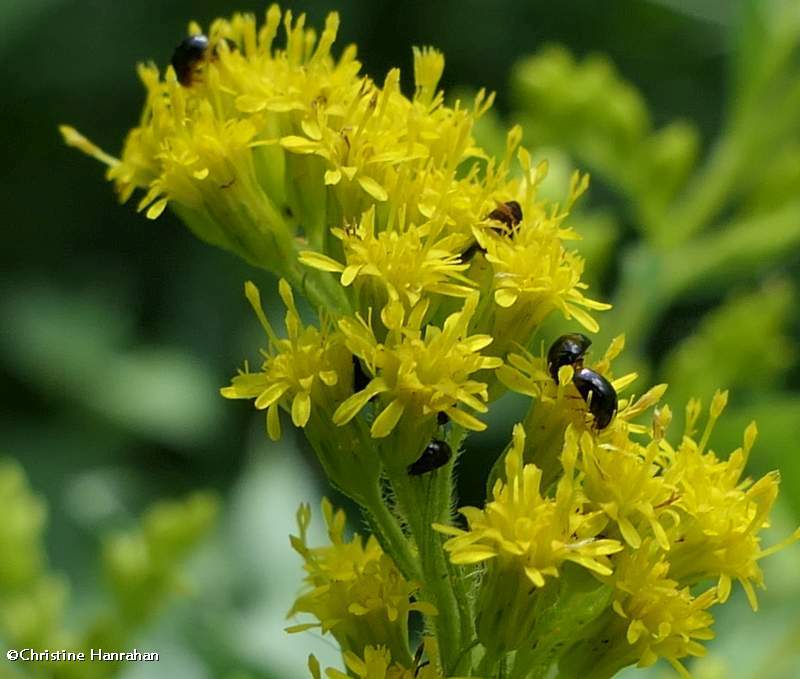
[511,47,698,229]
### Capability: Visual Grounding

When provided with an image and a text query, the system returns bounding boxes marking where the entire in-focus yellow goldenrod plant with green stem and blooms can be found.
[62,6,800,679]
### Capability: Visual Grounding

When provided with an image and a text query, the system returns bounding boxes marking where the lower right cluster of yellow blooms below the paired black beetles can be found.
[437,340,800,677]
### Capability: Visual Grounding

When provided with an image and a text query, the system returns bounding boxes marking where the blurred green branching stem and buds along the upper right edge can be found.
[511,0,800,407]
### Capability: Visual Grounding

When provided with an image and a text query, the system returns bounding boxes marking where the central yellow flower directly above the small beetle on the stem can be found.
[333,294,502,465]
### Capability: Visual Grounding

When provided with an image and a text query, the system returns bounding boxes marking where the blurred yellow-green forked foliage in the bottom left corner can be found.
[0,460,217,679]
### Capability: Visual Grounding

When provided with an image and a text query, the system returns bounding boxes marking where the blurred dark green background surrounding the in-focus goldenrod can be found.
[0,0,800,679]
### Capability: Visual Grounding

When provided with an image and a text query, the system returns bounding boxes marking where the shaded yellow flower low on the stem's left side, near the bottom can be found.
[289,499,436,665]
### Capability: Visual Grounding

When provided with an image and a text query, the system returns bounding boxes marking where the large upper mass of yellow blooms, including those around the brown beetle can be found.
[62,6,605,328]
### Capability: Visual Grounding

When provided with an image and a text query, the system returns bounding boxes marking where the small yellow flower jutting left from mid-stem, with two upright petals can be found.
[221,280,352,440]
